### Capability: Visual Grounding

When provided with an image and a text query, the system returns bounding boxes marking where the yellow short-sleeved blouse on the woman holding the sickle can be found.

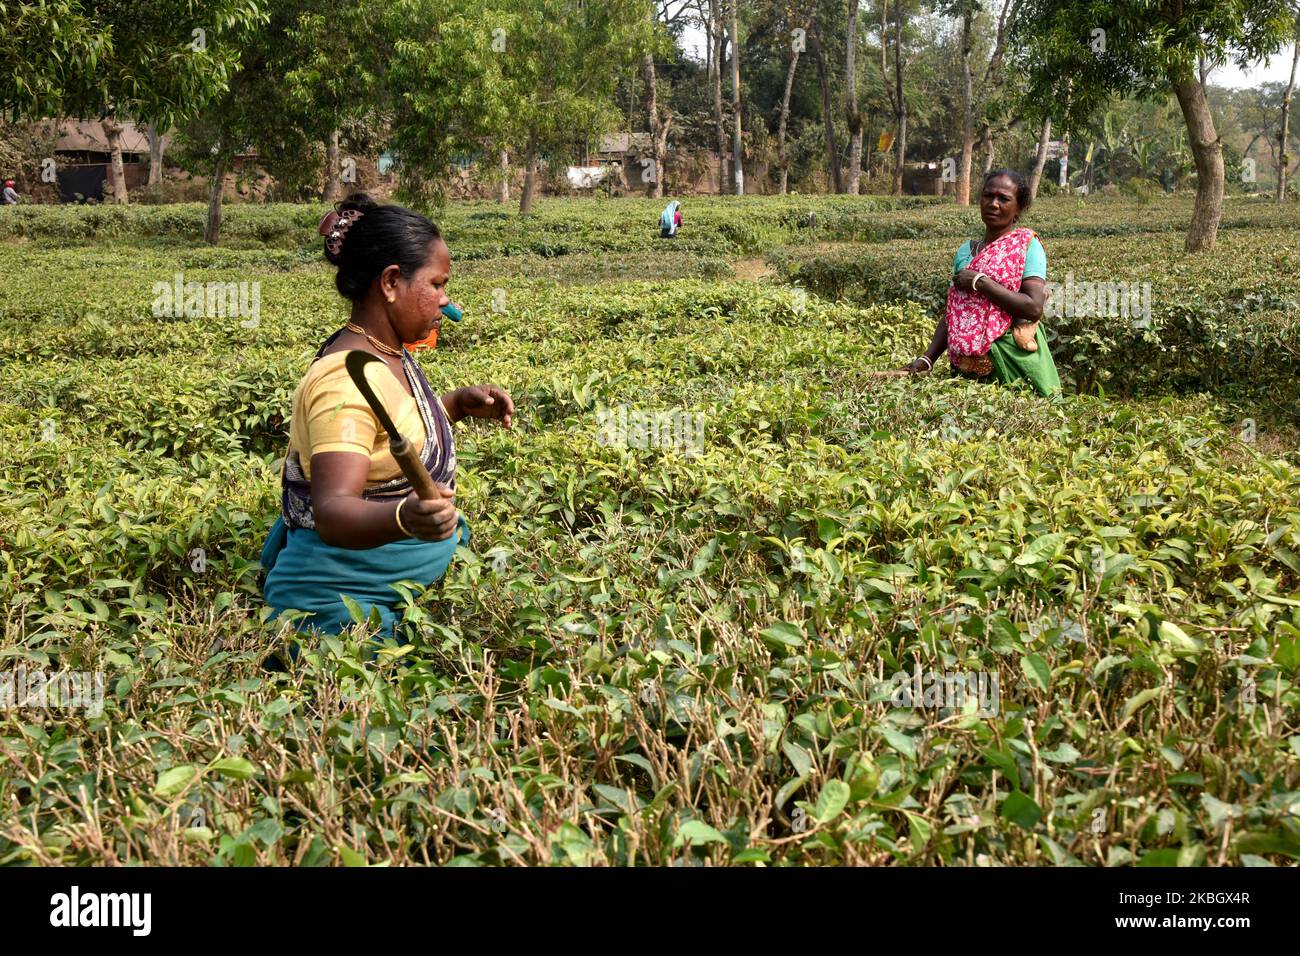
[303,363,406,458]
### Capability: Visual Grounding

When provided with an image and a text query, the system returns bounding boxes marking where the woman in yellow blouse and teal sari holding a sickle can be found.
[261,194,515,642]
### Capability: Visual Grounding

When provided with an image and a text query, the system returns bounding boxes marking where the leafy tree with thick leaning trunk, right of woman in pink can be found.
[1014,0,1295,252]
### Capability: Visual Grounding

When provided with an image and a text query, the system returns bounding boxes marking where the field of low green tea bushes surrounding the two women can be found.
[0,198,1300,865]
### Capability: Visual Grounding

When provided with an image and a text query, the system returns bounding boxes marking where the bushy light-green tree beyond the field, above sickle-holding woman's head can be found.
[386,0,650,215]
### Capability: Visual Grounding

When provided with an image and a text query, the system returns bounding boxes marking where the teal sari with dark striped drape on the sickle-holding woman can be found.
[261,333,469,633]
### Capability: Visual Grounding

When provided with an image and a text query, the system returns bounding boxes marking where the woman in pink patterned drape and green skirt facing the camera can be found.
[905,169,1061,395]
